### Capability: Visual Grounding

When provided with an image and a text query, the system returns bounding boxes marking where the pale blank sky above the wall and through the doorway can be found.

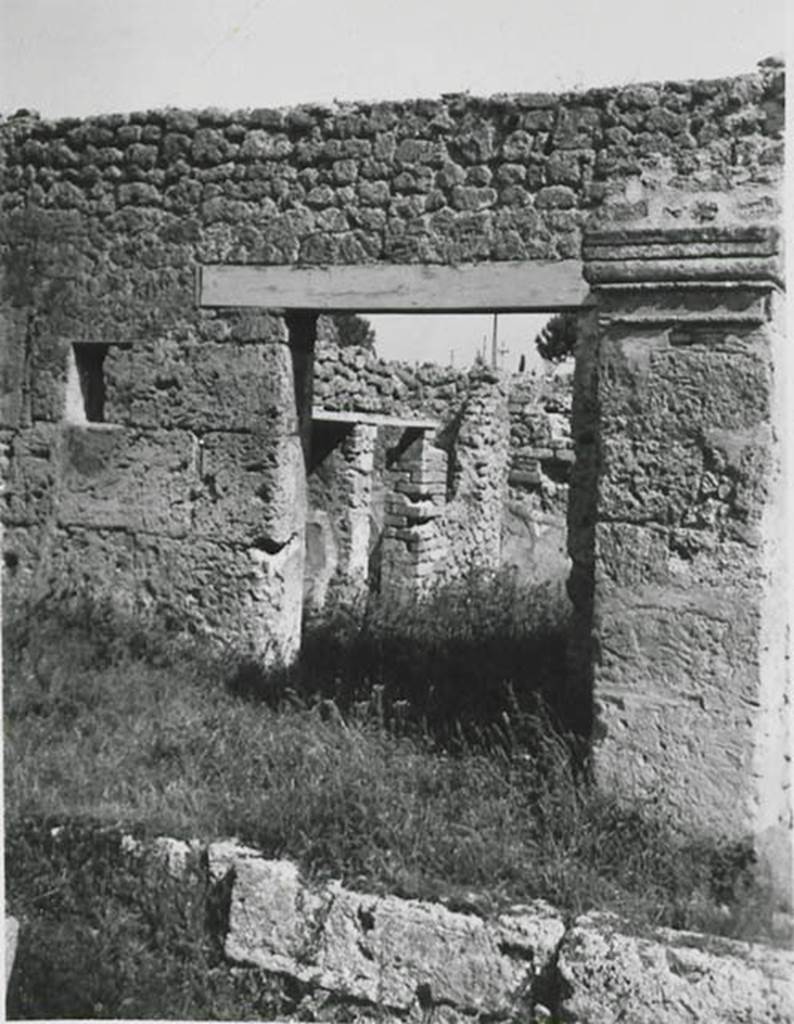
[0,0,786,365]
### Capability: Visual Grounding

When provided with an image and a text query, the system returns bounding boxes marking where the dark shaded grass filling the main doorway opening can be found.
[298,567,590,746]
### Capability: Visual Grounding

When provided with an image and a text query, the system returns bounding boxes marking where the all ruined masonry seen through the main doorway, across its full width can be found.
[307,341,574,605]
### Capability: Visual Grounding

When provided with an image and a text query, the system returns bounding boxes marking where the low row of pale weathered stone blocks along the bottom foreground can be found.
[13,837,782,1024]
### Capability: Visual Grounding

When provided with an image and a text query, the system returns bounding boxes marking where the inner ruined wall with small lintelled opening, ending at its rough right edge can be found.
[305,335,516,609]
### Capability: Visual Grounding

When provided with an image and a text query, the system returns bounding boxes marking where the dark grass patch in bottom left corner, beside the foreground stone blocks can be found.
[6,821,303,1020]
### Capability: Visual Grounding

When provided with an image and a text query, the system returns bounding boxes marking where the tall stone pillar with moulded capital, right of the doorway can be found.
[570,227,792,891]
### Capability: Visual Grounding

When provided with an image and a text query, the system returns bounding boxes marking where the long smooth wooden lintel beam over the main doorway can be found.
[198,259,588,313]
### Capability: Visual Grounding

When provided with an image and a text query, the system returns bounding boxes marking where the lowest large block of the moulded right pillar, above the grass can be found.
[594,581,761,839]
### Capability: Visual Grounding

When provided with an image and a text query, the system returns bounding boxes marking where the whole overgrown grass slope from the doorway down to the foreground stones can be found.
[5,579,786,1017]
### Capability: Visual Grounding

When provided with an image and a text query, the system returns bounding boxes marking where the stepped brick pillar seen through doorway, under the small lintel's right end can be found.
[380,431,447,594]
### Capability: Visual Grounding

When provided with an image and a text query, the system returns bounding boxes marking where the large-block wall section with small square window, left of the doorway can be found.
[2,307,304,656]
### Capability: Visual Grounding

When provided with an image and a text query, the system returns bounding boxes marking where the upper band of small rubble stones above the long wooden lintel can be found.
[3,68,783,266]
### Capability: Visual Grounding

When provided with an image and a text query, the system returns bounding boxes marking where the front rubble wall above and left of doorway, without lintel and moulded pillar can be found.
[0,68,783,639]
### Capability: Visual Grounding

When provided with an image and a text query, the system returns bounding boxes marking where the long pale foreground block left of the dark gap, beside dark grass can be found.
[213,851,565,1017]
